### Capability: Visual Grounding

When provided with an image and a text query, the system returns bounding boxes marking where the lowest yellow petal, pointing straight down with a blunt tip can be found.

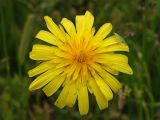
[78,86,89,115]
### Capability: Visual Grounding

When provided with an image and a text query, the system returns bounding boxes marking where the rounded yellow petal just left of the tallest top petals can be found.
[61,18,76,37]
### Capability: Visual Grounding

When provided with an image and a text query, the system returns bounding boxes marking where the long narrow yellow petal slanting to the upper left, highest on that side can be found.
[44,16,65,41]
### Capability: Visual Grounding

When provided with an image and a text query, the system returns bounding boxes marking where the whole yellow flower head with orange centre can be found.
[28,11,133,115]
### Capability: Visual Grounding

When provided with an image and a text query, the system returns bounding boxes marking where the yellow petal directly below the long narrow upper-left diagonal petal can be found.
[36,30,62,45]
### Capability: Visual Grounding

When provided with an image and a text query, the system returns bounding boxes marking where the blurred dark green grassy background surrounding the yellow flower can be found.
[0,0,160,120]
